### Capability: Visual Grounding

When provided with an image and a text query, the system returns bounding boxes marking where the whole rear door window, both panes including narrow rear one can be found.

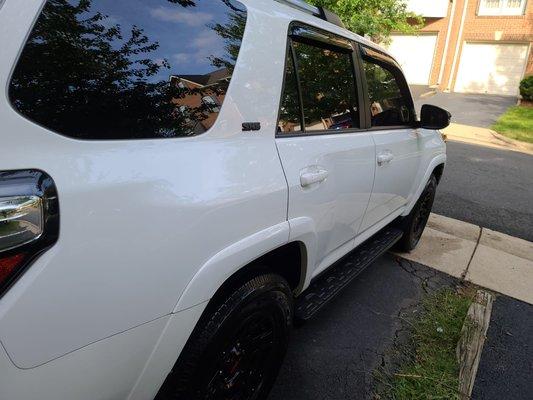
[278,25,360,134]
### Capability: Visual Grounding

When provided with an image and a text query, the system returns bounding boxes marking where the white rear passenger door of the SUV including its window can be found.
[276,25,375,274]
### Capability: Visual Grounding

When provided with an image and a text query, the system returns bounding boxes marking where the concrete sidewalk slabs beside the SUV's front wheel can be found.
[398,214,533,304]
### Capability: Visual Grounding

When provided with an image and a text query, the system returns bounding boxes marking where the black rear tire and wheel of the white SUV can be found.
[156,274,293,400]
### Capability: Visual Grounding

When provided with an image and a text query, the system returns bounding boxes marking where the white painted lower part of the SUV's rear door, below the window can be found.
[276,132,375,273]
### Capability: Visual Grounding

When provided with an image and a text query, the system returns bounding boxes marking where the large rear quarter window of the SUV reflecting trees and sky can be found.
[10,0,246,139]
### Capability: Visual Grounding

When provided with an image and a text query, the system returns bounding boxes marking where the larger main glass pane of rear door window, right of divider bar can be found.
[293,42,359,131]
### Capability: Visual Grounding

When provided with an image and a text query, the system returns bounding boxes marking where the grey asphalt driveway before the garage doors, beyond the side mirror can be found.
[413,90,516,128]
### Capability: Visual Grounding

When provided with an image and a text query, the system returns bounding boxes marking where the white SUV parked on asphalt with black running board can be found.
[0,0,450,400]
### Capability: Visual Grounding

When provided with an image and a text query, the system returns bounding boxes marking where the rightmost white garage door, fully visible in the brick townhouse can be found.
[455,43,528,96]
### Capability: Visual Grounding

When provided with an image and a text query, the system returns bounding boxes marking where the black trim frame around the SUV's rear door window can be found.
[275,21,367,139]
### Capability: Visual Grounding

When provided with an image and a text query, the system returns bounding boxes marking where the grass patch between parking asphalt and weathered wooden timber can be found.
[376,288,473,400]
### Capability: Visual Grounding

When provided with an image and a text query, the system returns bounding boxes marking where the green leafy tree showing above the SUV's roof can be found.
[309,0,422,42]
